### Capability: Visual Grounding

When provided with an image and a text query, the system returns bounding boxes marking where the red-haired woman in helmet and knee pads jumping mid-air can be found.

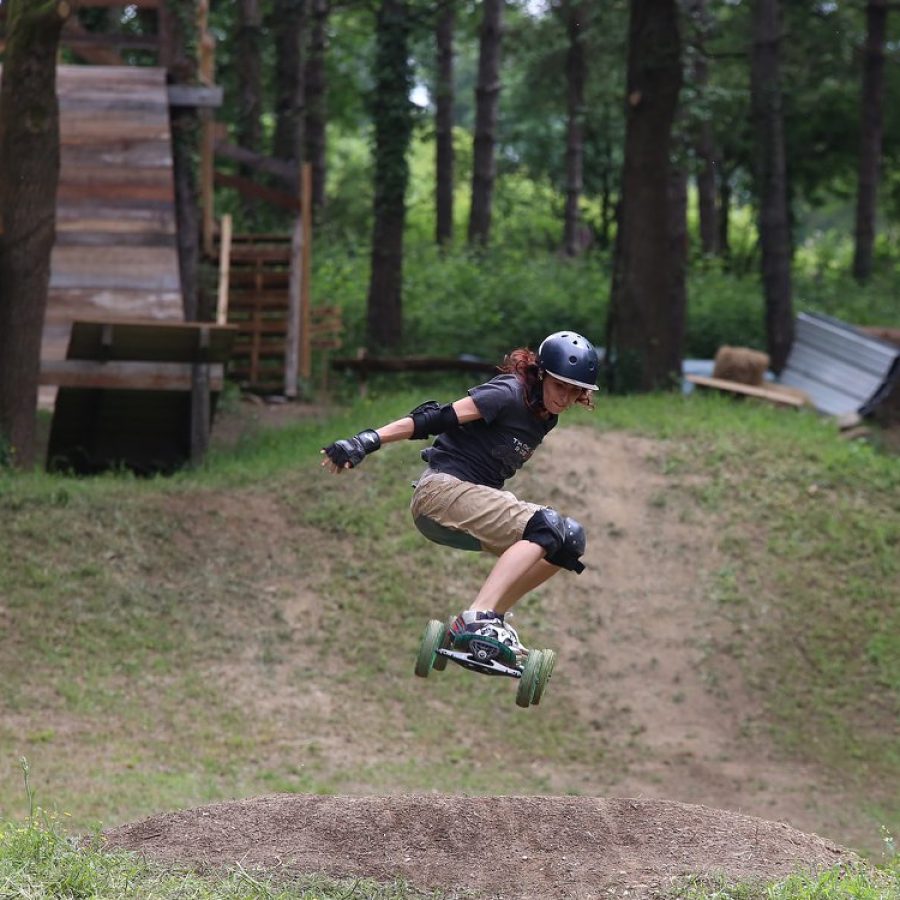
[322,331,598,661]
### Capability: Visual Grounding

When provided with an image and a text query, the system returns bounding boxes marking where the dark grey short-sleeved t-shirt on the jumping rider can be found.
[426,375,557,488]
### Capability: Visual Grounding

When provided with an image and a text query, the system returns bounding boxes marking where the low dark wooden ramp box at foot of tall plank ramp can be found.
[41,318,234,475]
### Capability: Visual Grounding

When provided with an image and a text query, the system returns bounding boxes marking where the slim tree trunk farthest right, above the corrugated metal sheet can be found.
[853,0,888,284]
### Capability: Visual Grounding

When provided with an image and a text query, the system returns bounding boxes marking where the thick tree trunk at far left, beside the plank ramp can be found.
[0,0,70,468]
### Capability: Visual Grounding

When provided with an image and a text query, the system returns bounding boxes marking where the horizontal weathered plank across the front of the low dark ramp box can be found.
[39,359,225,391]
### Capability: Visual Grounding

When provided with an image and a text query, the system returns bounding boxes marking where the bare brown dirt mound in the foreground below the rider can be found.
[106,794,850,900]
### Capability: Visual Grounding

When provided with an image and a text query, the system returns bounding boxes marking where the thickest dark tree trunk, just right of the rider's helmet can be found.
[607,0,684,390]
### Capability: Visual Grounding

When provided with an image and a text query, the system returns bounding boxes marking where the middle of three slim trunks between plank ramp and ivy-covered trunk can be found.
[272,0,306,196]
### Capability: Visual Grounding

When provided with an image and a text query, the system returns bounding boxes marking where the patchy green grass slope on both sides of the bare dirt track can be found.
[0,379,900,852]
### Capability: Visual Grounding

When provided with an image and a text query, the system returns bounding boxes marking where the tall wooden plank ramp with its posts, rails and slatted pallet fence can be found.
[0,0,326,406]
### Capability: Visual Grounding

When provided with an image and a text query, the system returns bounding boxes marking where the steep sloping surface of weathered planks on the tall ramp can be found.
[42,66,184,402]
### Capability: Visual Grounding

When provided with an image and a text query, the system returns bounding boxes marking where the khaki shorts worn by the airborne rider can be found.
[410,469,542,556]
